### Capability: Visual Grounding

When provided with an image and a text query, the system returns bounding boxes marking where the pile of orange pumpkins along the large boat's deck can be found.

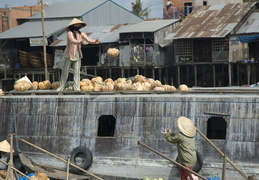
[14,75,188,91]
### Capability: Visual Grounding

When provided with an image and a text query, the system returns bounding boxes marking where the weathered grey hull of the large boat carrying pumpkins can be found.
[0,88,259,179]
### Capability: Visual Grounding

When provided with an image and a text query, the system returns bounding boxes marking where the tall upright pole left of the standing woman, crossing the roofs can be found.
[40,0,49,80]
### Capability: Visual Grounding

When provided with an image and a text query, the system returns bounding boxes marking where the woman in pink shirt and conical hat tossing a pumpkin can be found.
[57,18,100,91]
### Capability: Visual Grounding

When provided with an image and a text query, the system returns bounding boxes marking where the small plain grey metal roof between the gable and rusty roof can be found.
[121,19,180,33]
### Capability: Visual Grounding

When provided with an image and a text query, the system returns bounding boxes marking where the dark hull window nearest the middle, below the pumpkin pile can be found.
[97,115,116,137]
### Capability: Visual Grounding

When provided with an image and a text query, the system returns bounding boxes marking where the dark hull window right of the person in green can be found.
[207,117,227,139]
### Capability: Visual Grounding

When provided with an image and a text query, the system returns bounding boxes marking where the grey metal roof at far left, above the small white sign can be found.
[0,20,70,39]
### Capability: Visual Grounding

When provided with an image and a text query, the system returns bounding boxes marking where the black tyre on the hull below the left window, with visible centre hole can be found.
[70,146,93,172]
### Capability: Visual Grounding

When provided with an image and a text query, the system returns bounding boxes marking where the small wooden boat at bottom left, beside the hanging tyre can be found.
[19,153,89,180]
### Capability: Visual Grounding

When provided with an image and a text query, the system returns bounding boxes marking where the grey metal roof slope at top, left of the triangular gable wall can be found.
[23,0,107,19]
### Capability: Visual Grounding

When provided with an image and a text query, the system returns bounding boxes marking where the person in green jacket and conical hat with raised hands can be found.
[162,116,197,180]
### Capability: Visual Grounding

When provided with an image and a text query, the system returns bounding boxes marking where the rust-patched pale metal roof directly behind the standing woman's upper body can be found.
[50,24,132,46]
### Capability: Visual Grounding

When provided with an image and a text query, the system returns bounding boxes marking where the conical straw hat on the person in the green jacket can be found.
[177,116,196,137]
